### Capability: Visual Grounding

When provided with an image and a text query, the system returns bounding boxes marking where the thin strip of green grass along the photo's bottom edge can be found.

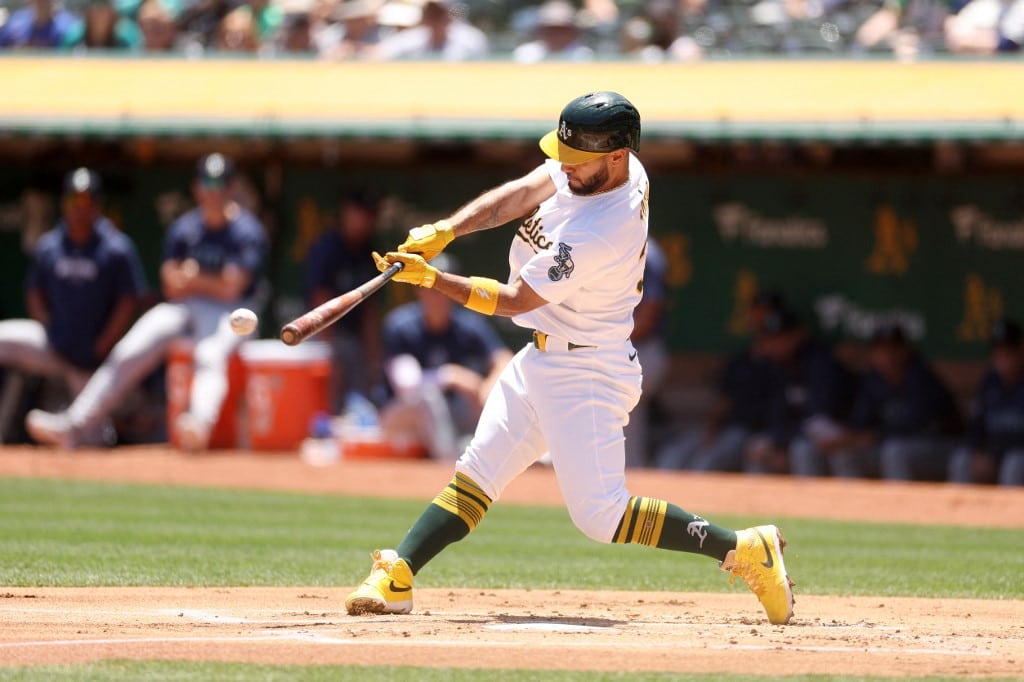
[0,660,1009,682]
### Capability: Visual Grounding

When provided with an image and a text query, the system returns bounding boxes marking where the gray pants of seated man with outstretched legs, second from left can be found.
[68,298,244,430]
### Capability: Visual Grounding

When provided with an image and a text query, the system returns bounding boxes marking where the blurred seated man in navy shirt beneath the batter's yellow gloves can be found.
[380,254,512,461]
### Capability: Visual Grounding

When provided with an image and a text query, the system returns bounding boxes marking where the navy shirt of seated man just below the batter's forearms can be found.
[384,303,505,375]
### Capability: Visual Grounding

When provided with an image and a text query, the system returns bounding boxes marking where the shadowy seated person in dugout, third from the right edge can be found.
[745,309,856,477]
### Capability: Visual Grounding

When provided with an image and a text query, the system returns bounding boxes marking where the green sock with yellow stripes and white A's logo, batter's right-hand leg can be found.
[614,497,736,561]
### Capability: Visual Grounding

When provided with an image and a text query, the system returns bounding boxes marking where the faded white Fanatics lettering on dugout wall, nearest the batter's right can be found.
[713,202,828,249]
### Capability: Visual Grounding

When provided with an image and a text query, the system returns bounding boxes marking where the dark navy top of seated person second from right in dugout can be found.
[849,356,961,439]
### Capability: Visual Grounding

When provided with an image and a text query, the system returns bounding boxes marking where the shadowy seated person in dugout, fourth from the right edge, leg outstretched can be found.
[655,291,782,471]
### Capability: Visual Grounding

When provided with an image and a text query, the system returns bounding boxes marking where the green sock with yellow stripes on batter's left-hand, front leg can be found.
[395,473,490,574]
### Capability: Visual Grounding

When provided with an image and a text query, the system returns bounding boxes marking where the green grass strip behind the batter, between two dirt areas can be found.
[0,478,1024,599]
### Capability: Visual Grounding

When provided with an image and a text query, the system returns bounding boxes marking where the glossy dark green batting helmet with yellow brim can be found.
[541,91,640,165]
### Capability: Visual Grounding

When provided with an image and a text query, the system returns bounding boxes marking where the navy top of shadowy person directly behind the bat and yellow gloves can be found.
[303,229,378,334]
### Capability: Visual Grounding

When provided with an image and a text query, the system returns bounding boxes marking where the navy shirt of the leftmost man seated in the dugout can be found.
[27,218,146,369]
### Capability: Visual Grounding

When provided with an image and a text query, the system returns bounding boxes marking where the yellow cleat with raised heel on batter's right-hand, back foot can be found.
[722,525,794,625]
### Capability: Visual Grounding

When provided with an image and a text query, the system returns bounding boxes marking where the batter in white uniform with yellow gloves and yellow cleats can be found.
[345,92,793,624]
